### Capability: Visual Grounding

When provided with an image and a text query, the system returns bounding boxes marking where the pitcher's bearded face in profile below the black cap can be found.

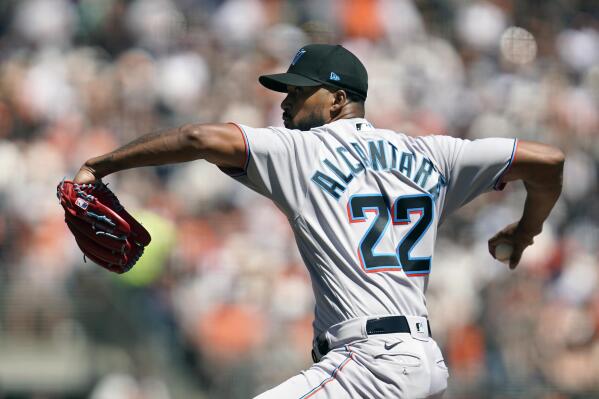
[281,86,332,130]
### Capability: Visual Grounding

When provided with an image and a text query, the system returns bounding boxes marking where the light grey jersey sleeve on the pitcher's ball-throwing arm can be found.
[423,136,518,223]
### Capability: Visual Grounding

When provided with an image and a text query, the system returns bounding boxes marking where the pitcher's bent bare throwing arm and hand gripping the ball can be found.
[489,140,565,269]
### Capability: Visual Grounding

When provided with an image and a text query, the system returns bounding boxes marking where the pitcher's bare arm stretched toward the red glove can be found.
[73,123,247,183]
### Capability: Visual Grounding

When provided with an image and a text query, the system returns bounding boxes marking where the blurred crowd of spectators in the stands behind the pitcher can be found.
[0,0,599,399]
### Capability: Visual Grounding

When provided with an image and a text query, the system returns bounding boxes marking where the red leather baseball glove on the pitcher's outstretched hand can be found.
[56,180,151,274]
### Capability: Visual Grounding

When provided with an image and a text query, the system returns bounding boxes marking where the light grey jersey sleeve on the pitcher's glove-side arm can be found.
[221,124,318,217]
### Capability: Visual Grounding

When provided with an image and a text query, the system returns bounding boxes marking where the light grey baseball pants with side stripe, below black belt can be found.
[255,317,449,399]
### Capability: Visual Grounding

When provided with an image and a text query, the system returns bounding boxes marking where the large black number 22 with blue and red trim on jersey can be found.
[347,194,435,276]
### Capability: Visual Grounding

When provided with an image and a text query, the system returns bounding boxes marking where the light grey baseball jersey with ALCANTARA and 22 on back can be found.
[225,118,516,334]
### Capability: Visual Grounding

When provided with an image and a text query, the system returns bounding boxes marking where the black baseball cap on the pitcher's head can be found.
[258,44,368,100]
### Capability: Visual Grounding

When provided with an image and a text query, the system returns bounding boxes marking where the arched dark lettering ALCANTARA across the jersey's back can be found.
[312,140,447,200]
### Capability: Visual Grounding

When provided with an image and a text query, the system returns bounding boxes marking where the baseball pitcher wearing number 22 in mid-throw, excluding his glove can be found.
[74,44,564,399]
